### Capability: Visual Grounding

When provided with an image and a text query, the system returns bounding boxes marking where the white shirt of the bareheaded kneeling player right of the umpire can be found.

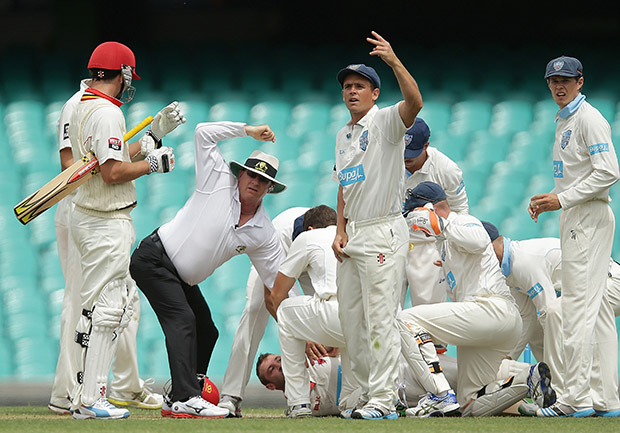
[280,225,337,300]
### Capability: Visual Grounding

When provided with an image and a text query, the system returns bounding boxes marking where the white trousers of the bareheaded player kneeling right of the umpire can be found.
[277,296,357,406]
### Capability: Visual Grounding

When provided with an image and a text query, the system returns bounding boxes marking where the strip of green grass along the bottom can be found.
[0,406,620,433]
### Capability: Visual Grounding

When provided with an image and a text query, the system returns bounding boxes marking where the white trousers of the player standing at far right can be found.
[554,200,620,410]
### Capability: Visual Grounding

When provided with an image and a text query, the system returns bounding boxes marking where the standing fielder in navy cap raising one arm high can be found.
[332,32,422,419]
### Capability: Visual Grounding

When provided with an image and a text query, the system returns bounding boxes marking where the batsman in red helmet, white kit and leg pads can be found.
[69,42,184,419]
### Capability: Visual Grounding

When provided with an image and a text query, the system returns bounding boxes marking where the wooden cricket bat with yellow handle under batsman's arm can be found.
[13,116,153,225]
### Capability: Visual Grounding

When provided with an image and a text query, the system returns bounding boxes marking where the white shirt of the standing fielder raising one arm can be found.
[334,104,407,222]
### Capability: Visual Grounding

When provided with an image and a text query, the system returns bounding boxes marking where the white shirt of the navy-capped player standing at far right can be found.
[553,94,620,209]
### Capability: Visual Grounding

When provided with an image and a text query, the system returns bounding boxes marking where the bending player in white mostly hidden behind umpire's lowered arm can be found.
[218,207,312,417]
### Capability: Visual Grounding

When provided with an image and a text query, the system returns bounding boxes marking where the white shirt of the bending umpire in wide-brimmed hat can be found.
[159,122,284,287]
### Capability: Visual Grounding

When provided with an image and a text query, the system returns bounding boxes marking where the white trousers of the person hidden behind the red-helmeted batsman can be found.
[50,194,144,407]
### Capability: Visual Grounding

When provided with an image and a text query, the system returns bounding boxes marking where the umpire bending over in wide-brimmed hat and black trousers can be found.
[130,122,286,418]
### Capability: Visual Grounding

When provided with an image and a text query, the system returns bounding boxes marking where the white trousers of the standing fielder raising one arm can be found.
[336,215,409,410]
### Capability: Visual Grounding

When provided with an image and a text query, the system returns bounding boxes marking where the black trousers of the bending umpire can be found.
[129,230,218,402]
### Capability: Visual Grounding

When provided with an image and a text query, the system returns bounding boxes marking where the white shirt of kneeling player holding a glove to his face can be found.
[439,212,512,302]
